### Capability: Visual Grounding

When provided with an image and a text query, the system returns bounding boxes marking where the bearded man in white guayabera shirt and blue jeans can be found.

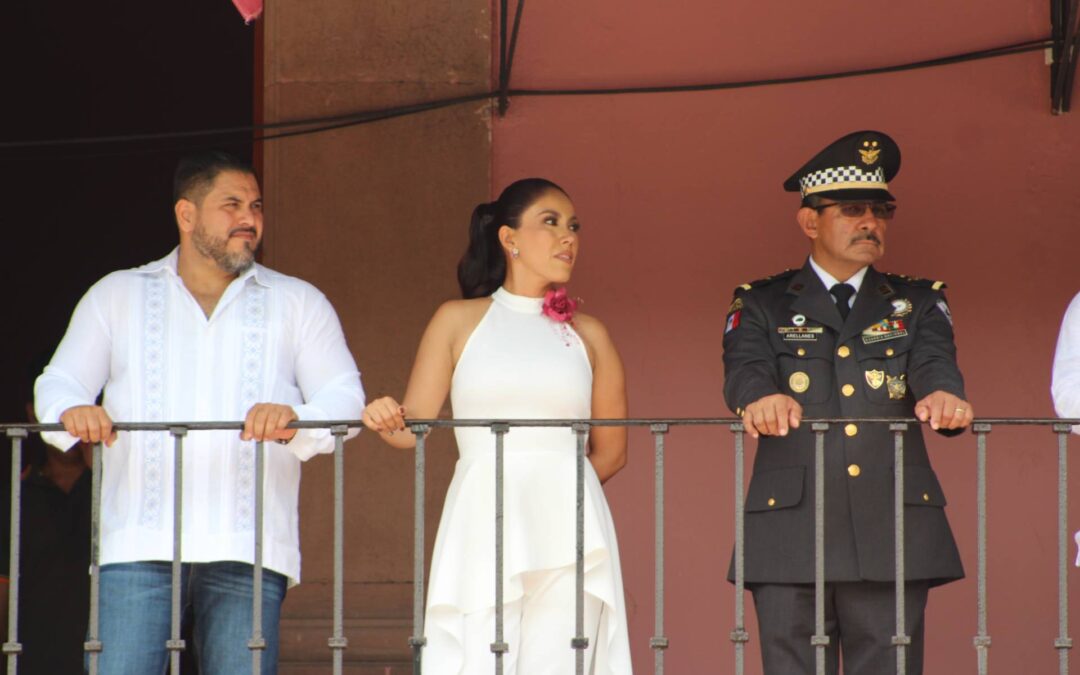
[35,152,364,675]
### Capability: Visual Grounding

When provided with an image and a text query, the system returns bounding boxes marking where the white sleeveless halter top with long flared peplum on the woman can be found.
[423,288,631,675]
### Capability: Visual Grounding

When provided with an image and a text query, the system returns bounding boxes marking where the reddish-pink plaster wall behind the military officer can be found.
[492,0,1080,674]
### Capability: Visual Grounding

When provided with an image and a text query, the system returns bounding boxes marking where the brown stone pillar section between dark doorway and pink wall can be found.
[262,0,490,675]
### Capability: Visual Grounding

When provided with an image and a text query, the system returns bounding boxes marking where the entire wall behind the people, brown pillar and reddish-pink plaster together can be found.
[264,0,1080,674]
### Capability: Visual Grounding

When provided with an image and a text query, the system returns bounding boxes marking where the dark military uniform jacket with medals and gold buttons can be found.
[724,261,966,584]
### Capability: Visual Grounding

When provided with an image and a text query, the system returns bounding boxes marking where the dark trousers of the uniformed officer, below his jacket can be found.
[751,581,930,675]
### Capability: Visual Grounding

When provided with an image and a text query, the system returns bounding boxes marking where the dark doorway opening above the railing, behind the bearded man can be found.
[0,0,256,422]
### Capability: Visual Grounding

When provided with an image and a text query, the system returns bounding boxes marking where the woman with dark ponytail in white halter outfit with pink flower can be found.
[363,178,631,675]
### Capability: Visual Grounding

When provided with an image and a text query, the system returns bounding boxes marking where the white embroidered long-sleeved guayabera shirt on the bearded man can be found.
[35,249,364,583]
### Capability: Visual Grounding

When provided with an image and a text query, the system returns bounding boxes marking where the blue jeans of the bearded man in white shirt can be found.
[95,562,286,675]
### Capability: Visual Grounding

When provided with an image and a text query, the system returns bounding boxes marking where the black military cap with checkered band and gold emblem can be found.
[784,131,900,202]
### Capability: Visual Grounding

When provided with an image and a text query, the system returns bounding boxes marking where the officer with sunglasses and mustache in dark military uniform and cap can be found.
[724,131,973,675]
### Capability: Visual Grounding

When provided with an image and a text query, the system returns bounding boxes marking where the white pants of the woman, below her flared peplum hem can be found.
[460,567,606,675]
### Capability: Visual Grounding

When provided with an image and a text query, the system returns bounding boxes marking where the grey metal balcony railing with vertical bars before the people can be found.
[0,418,1080,675]
